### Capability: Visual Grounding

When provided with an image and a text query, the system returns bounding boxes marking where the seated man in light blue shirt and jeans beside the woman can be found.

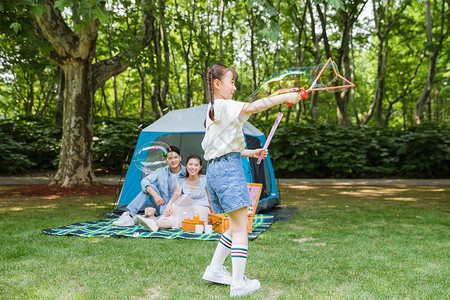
[112,146,186,226]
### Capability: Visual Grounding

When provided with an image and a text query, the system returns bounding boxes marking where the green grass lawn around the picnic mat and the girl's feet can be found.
[0,187,450,299]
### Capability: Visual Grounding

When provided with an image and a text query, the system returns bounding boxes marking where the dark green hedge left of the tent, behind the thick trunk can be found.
[0,116,146,175]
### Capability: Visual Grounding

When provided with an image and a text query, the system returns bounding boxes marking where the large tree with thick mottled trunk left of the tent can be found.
[18,0,154,187]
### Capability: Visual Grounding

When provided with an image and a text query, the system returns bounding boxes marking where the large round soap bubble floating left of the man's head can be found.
[133,141,170,174]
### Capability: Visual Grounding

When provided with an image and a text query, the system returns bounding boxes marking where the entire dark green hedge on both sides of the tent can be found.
[0,116,450,178]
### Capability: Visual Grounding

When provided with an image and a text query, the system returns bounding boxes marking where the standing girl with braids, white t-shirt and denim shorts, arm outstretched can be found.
[202,64,301,296]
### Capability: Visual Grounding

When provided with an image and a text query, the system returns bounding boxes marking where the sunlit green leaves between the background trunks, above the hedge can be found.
[0,0,450,128]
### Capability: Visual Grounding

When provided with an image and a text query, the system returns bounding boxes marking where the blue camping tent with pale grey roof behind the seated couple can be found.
[114,104,279,213]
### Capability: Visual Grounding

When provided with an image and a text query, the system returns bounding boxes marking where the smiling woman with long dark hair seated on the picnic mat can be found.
[136,154,212,232]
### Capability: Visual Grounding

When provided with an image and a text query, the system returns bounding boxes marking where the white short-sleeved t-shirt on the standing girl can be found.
[202,99,250,161]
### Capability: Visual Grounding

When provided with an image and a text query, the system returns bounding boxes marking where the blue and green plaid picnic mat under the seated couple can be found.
[42,214,274,241]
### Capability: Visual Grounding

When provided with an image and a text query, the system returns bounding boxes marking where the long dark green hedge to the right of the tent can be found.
[270,124,450,178]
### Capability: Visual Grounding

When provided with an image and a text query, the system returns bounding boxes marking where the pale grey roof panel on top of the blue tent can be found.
[143,104,263,136]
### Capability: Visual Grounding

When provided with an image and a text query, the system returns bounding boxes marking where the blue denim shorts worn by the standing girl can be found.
[206,152,250,214]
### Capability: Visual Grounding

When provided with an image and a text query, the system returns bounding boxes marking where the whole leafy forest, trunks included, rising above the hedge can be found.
[0,0,450,175]
